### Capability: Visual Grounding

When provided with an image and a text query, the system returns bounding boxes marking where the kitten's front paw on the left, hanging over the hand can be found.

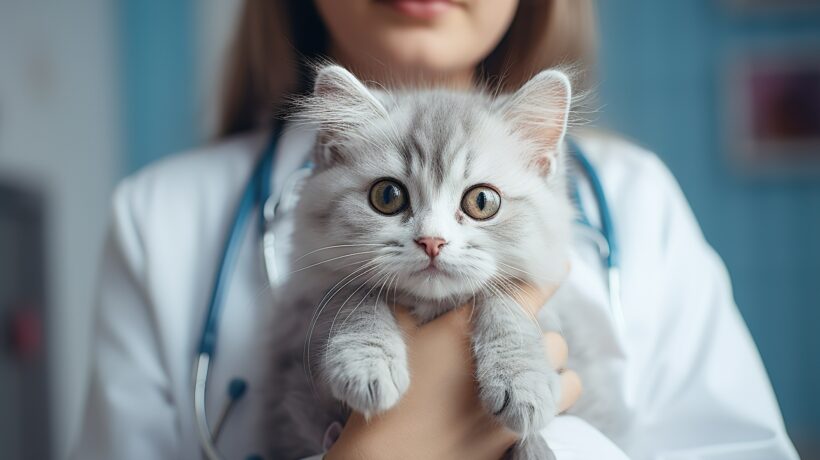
[330,358,410,417]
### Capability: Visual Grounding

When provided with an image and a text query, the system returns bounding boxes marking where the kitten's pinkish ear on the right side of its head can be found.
[501,70,572,176]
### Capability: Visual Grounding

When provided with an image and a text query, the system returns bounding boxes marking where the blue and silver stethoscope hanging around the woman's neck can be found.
[194,123,623,460]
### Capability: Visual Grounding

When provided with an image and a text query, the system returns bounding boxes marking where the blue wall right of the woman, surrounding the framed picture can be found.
[599,0,820,437]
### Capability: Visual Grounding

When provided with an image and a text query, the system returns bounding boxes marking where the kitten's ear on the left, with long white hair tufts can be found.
[307,65,387,166]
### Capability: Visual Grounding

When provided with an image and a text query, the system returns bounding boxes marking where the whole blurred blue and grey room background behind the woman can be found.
[0,0,820,459]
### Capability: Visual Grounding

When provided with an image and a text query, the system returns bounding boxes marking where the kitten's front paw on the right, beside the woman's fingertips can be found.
[479,366,559,436]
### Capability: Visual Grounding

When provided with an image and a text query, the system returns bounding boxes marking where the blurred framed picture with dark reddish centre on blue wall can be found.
[724,46,820,174]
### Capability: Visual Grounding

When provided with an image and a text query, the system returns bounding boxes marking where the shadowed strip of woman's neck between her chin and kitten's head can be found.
[329,44,475,89]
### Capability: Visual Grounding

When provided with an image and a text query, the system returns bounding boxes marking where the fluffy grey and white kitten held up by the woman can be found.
[267,66,573,459]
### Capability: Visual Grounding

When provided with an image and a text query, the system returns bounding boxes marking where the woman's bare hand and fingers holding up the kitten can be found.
[326,274,581,460]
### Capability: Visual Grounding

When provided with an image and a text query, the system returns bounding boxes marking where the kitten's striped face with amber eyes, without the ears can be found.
[294,64,571,300]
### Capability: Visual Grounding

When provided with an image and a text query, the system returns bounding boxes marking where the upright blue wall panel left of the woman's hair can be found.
[119,0,198,173]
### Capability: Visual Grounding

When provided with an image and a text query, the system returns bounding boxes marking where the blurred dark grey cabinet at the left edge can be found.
[0,180,51,460]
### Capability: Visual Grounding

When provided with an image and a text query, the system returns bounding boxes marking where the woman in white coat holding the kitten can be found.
[76,0,796,459]
